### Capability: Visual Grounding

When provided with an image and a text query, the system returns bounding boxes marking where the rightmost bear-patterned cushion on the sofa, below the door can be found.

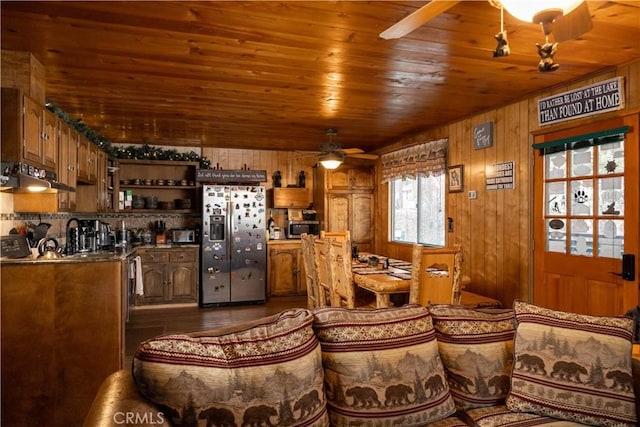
[506,301,636,426]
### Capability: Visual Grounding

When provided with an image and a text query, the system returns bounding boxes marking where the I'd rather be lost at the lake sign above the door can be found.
[538,76,624,126]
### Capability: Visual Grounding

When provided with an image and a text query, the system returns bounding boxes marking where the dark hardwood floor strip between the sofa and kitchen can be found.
[124,296,307,369]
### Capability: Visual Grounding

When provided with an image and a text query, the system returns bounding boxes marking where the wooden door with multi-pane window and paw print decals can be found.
[534,115,640,315]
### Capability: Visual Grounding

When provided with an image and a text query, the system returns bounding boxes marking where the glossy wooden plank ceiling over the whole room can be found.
[0,0,640,155]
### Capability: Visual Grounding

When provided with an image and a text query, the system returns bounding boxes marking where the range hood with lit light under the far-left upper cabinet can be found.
[0,162,76,193]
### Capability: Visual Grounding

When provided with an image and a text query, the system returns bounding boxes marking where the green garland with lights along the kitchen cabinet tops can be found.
[45,101,211,169]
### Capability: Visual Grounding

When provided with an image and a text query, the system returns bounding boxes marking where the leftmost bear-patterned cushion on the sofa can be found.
[133,309,328,426]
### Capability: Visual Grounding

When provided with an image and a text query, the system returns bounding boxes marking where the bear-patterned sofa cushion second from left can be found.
[313,306,455,426]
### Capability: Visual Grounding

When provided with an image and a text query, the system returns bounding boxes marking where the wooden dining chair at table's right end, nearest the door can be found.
[409,245,462,306]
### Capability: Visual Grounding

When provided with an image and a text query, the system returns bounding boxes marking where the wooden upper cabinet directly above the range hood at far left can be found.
[2,88,58,172]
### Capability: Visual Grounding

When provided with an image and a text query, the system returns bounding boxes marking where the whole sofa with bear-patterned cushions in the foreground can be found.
[84,301,640,427]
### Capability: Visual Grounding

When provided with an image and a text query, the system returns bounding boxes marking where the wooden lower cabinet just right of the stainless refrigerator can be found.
[267,240,307,296]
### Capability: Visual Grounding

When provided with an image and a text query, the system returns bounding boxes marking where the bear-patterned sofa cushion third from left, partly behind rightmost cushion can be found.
[429,305,515,409]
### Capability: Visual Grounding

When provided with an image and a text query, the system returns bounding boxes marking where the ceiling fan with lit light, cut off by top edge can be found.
[380,0,593,42]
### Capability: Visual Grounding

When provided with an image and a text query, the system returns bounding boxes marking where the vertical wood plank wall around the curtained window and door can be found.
[376,60,640,307]
